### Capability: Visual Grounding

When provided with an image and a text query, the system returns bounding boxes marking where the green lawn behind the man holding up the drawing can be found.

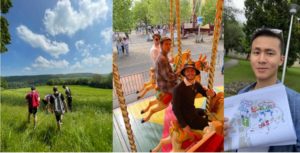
[224,57,300,92]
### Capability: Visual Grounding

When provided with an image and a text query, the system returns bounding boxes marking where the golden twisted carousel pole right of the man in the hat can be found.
[206,0,224,114]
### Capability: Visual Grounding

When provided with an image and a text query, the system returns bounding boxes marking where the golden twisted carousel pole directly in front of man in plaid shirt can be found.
[175,0,182,71]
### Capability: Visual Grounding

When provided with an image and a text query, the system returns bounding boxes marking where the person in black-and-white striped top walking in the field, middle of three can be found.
[50,86,66,130]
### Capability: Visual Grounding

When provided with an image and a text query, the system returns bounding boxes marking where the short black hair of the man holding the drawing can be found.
[251,28,284,54]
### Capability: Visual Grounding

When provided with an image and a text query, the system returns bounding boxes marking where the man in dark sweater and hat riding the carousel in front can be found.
[172,61,216,133]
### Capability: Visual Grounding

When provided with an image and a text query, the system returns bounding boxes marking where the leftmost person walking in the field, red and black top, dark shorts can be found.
[25,86,40,129]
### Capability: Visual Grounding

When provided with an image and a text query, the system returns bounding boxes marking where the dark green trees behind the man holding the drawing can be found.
[243,0,300,66]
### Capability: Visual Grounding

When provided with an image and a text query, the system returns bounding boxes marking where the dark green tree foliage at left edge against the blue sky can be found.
[0,0,12,53]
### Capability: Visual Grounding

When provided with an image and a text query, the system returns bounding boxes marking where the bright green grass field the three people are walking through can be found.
[1,86,112,152]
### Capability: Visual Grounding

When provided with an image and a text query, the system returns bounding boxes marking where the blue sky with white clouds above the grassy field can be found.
[1,0,112,76]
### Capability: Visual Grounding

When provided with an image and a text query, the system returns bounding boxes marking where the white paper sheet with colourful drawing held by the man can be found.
[224,84,297,150]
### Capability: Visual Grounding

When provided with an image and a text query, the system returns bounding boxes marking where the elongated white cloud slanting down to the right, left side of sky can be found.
[17,25,69,58]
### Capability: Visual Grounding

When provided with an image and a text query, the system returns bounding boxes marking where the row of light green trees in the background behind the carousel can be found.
[113,0,217,33]
